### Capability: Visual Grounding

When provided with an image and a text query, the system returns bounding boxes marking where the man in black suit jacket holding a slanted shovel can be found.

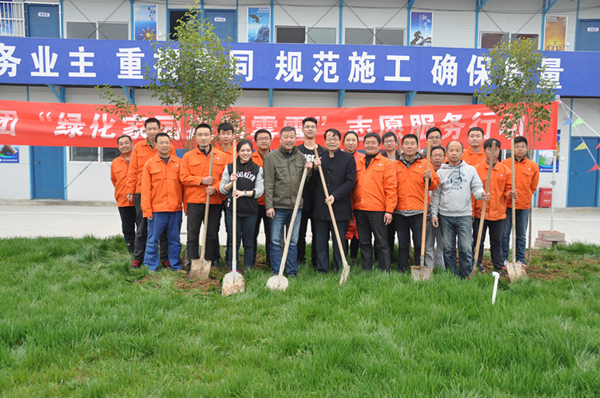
[313,129,356,273]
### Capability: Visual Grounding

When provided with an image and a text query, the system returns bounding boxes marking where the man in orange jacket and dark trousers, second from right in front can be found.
[473,138,517,271]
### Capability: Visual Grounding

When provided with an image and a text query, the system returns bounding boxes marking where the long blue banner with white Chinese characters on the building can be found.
[0,37,600,97]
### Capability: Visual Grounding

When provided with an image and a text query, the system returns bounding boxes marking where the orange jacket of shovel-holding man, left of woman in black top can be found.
[181,146,227,205]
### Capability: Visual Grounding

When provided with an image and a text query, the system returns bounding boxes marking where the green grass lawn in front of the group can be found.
[0,237,600,397]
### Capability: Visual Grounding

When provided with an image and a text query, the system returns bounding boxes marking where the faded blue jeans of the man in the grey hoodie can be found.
[438,215,473,279]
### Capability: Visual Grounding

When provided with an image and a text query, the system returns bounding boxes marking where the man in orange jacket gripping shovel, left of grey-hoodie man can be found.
[394,134,440,272]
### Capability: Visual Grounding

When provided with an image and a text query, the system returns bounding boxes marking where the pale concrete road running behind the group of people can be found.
[0,201,600,245]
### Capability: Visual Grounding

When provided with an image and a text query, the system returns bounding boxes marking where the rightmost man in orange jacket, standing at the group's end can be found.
[502,137,540,265]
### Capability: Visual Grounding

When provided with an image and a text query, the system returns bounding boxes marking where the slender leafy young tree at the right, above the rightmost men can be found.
[475,39,556,260]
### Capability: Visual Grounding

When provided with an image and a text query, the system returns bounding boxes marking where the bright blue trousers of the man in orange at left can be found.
[144,211,181,271]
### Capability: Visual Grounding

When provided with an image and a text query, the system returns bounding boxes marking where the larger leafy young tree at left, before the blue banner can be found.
[97,2,243,149]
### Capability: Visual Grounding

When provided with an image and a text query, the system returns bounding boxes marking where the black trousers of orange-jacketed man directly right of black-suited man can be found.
[354,210,391,272]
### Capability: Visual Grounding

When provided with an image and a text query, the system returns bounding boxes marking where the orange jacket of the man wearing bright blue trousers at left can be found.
[142,154,183,218]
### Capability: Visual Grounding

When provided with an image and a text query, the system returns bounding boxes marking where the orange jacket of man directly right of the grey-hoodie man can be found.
[473,162,512,221]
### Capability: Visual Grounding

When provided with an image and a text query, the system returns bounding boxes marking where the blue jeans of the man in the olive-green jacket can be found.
[270,209,302,276]
